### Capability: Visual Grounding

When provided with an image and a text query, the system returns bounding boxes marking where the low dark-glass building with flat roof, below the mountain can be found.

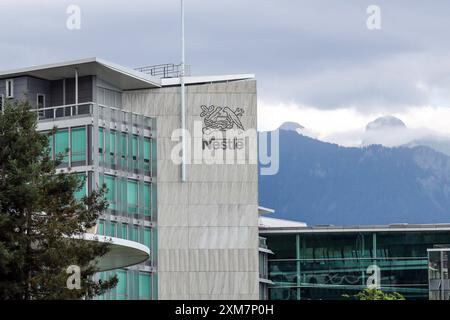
[261,218,450,300]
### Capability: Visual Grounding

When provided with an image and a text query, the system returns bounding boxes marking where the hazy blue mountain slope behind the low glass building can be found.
[259,124,450,225]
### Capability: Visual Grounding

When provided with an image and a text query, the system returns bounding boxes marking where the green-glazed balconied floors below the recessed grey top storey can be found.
[40,104,157,299]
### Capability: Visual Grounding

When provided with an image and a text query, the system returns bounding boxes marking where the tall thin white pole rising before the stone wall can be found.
[180,0,186,182]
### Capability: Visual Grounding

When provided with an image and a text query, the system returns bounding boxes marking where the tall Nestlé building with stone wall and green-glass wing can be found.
[0,58,259,299]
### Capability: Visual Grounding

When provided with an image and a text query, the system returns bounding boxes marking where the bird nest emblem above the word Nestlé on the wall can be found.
[200,105,245,135]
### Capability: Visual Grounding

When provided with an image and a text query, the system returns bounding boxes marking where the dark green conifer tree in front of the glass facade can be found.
[0,102,117,300]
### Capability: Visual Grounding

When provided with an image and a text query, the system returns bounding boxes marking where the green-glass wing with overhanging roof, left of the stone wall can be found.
[0,65,157,299]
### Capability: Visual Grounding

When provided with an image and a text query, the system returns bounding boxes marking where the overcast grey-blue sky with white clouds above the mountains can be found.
[0,0,450,144]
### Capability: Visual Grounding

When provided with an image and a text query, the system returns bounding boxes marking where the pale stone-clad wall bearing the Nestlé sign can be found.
[123,80,258,299]
